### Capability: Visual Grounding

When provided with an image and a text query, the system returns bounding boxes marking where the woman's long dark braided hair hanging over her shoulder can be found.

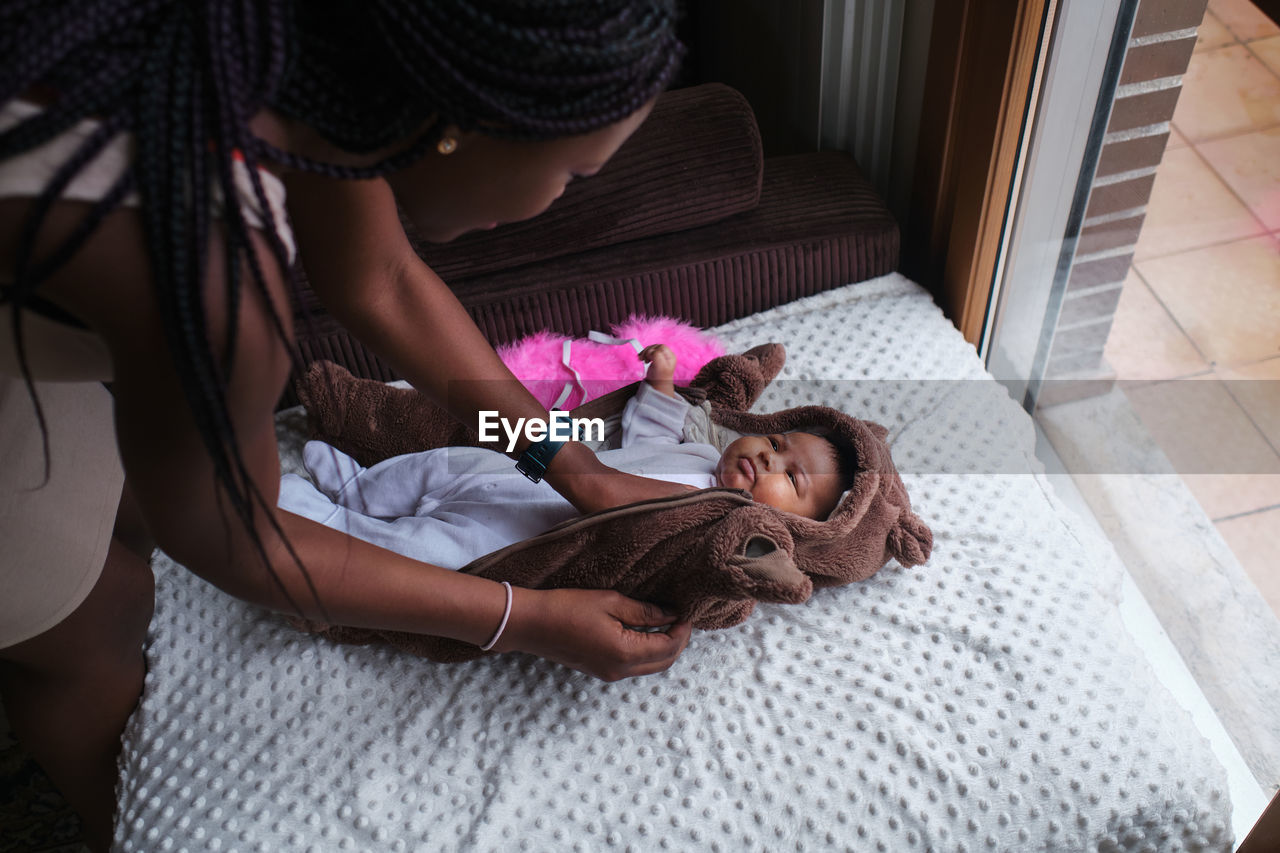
[0,0,681,607]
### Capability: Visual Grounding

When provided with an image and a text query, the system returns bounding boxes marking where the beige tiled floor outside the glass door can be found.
[1106,0,1280,615]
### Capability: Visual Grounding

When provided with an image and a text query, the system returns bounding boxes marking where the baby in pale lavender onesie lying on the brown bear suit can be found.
[279,345,854,569]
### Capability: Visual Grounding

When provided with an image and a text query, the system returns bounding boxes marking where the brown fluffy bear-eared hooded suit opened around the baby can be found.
[290,345,933,662]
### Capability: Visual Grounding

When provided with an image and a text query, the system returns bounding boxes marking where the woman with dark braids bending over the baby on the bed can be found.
[0,0,689,847]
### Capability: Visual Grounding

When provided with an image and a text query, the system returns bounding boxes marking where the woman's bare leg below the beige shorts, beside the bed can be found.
[0,538,155,850]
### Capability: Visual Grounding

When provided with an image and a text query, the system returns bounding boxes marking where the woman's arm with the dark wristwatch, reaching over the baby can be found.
[277,174,682,511]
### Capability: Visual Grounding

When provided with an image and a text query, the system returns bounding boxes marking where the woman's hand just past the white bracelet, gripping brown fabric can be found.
[494,588,691,681]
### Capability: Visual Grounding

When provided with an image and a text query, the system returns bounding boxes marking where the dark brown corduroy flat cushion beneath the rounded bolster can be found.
[289,151,899,389]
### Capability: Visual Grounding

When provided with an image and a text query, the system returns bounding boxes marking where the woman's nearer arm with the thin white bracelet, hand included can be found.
[60,211,689,679]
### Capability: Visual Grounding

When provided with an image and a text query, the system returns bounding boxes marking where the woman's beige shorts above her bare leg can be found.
[0,373,124,648]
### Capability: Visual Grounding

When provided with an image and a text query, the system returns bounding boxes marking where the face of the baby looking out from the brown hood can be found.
[716,433,840,521]
